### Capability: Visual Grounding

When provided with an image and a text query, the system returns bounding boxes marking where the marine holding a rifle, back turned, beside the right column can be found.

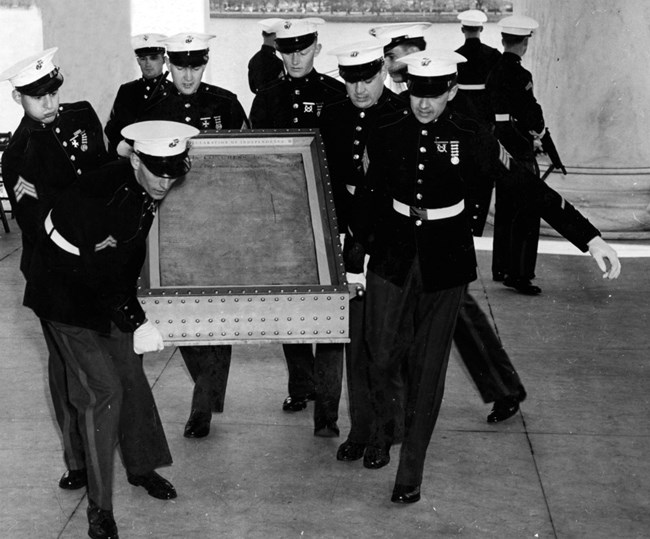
[486,15,545,295]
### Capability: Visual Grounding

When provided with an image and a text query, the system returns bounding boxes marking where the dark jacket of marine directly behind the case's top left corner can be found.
[142,82,247,131]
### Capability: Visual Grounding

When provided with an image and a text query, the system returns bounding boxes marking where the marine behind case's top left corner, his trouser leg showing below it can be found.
[140,32,247,438]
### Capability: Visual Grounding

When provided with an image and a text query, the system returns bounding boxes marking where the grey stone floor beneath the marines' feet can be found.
[0,228,650,539]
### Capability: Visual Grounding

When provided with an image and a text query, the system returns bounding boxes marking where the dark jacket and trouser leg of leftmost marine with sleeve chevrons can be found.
[2,101,107,476]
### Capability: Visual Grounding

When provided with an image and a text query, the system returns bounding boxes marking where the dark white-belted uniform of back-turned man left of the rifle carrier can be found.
[453,37,501,125]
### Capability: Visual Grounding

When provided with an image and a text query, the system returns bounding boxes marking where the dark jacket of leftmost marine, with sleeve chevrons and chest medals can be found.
[2,101,107,276]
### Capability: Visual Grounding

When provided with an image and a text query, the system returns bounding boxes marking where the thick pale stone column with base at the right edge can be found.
[514,0,650,239]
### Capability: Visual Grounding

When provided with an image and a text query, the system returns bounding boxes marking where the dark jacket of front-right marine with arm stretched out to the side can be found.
[361,108,598,291]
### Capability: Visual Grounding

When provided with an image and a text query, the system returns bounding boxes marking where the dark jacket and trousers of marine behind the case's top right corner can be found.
[250,69,345,431]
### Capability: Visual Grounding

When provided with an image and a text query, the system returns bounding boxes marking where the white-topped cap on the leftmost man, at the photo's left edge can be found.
[0,47,63,96]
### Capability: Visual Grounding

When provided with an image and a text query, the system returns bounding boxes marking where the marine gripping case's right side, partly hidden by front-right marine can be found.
[320,40,408,467]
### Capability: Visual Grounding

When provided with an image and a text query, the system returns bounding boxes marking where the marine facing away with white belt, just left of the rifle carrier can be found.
[454,9,501,125]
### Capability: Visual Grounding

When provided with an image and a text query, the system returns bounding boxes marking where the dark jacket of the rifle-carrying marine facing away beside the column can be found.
[486,52,545,160]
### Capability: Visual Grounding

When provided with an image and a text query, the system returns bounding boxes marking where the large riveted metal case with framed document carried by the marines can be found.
[139,129,349,345]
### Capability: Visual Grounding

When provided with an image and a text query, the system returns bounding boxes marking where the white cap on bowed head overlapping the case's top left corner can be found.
[121,120,199,178]
